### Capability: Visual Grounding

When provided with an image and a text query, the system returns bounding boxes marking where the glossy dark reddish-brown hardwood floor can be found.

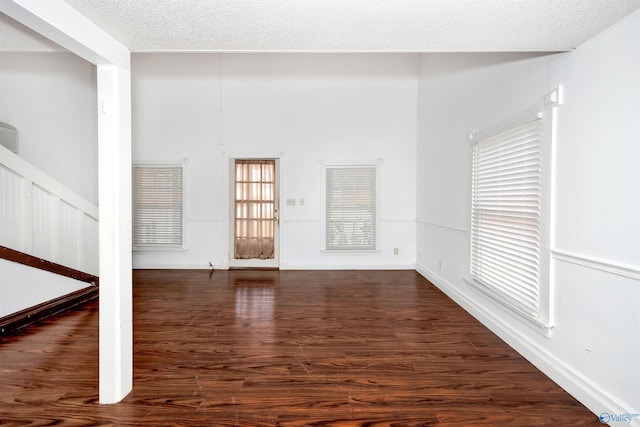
[0,270,601,426]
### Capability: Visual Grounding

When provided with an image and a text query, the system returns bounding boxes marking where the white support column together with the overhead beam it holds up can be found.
[0,0,133,403]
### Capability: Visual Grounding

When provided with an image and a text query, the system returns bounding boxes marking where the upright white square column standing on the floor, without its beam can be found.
[97,64,133,403]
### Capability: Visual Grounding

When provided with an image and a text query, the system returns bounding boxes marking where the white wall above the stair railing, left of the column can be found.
[0,52,98,204]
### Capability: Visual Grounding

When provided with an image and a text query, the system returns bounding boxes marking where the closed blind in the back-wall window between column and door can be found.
[132,165,183,248]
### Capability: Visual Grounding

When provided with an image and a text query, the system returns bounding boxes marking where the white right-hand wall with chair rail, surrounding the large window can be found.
[417,8,640,425]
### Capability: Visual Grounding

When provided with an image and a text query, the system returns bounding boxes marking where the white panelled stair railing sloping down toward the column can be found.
[0,146,98,276]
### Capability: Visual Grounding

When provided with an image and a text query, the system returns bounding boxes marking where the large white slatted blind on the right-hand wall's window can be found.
[471,119,542,317]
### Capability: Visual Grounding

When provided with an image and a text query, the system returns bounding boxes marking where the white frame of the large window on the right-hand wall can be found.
[465,86,561,337]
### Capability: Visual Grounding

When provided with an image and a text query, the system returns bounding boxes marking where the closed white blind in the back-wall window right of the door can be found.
[326,166,377,251]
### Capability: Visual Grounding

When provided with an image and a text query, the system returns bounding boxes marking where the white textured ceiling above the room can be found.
[0,0,640,52]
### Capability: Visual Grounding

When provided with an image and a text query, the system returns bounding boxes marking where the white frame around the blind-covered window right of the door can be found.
[320,160,382,254]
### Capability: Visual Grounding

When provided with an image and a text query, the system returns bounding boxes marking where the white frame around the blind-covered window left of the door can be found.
[131,159,190,253]
